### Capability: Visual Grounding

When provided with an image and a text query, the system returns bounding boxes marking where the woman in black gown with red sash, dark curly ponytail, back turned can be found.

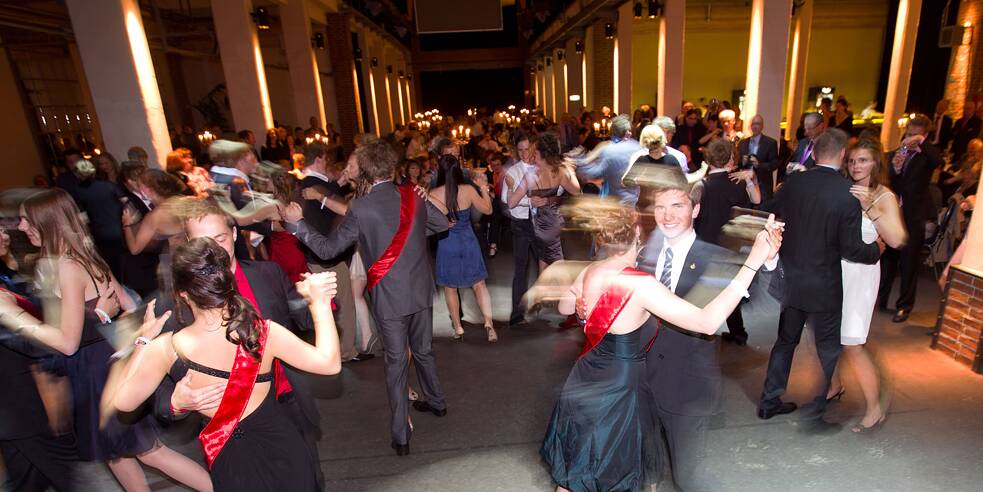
[112,238,341,491]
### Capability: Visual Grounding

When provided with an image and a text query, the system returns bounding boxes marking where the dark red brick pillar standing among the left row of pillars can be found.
[326,13,358,153]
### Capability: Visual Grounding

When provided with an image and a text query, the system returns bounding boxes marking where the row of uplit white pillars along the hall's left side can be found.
[66,0,412,163]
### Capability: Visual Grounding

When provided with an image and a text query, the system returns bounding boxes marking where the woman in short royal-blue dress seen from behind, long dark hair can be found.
[430,155,498,342]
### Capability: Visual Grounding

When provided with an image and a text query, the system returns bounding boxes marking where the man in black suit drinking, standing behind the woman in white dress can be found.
[877,115,943,323]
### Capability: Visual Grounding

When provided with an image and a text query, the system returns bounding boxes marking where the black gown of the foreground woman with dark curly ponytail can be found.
[169,358,319,492]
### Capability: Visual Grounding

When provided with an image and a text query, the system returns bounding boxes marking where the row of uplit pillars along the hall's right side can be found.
[534,0,921,148]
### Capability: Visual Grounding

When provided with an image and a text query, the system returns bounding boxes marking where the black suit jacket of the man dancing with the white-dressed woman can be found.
[774,165,880,313]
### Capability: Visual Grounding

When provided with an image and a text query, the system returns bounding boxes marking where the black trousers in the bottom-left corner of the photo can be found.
[0,434,78,492]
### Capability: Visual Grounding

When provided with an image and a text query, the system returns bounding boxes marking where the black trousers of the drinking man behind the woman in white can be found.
[877,220,925,310]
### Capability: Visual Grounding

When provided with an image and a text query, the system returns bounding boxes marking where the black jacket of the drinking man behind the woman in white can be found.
[887,143,943,225]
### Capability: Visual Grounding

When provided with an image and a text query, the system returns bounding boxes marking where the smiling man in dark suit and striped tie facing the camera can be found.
[638,170,768,492]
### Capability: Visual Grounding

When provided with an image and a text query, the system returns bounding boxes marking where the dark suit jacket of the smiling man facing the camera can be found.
[638,234,742,417]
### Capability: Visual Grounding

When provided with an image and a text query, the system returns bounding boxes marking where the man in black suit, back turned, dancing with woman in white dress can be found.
[758,128,883,430]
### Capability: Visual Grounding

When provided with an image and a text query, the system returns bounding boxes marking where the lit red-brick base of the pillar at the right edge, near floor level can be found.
[932,267,983,373]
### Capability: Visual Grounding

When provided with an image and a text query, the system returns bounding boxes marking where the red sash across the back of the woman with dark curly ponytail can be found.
[198,323,269,469]
